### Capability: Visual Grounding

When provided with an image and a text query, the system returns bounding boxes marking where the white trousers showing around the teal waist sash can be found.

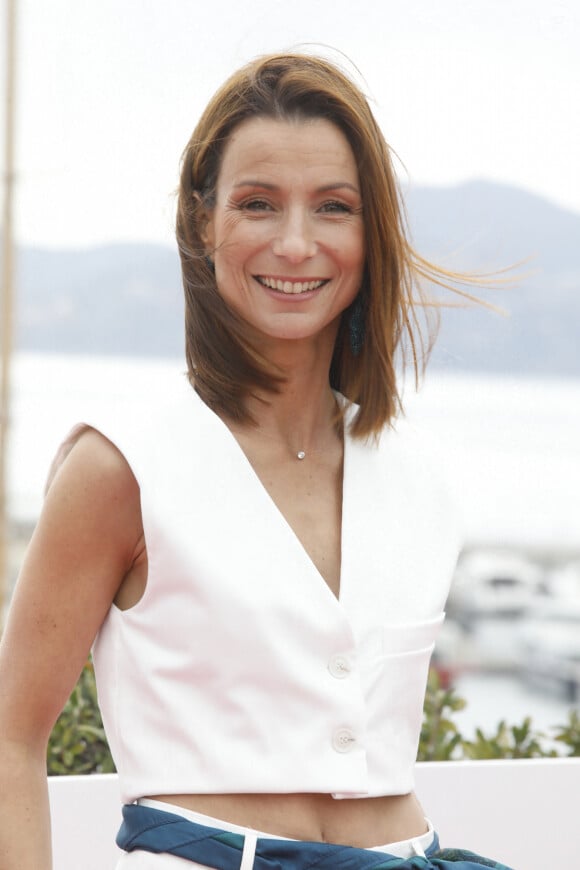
[116,799,434,870]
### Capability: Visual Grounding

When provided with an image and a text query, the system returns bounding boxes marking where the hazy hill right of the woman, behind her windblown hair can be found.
[407,182,580,375]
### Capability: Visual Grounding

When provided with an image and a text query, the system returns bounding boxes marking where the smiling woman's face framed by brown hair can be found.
[203,118,365,350]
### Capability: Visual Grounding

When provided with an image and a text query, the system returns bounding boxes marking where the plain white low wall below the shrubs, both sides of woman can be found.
[49,758,580,870]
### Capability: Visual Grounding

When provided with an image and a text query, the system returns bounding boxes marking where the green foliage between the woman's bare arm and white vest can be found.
[46,661,115,775]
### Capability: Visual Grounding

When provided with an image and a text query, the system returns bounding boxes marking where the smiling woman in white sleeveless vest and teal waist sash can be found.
[0,55,510,870]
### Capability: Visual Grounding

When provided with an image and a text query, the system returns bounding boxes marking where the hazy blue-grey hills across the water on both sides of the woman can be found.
[17,181,580,375]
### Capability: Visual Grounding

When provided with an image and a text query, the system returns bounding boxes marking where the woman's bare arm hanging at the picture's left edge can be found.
[0,430,143,870]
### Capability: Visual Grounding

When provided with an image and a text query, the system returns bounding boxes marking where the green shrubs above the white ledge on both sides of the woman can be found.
[47,661,580,775]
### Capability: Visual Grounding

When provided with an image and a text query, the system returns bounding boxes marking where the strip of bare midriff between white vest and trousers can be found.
[145,793,427,848]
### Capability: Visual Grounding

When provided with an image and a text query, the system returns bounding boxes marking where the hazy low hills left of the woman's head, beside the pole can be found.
[17,245,183,356]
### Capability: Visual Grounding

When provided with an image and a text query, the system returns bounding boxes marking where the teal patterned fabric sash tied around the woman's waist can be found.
[117,804,510,870]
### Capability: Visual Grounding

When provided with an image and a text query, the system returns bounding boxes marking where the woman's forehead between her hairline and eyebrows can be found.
[213,118,358,188]
